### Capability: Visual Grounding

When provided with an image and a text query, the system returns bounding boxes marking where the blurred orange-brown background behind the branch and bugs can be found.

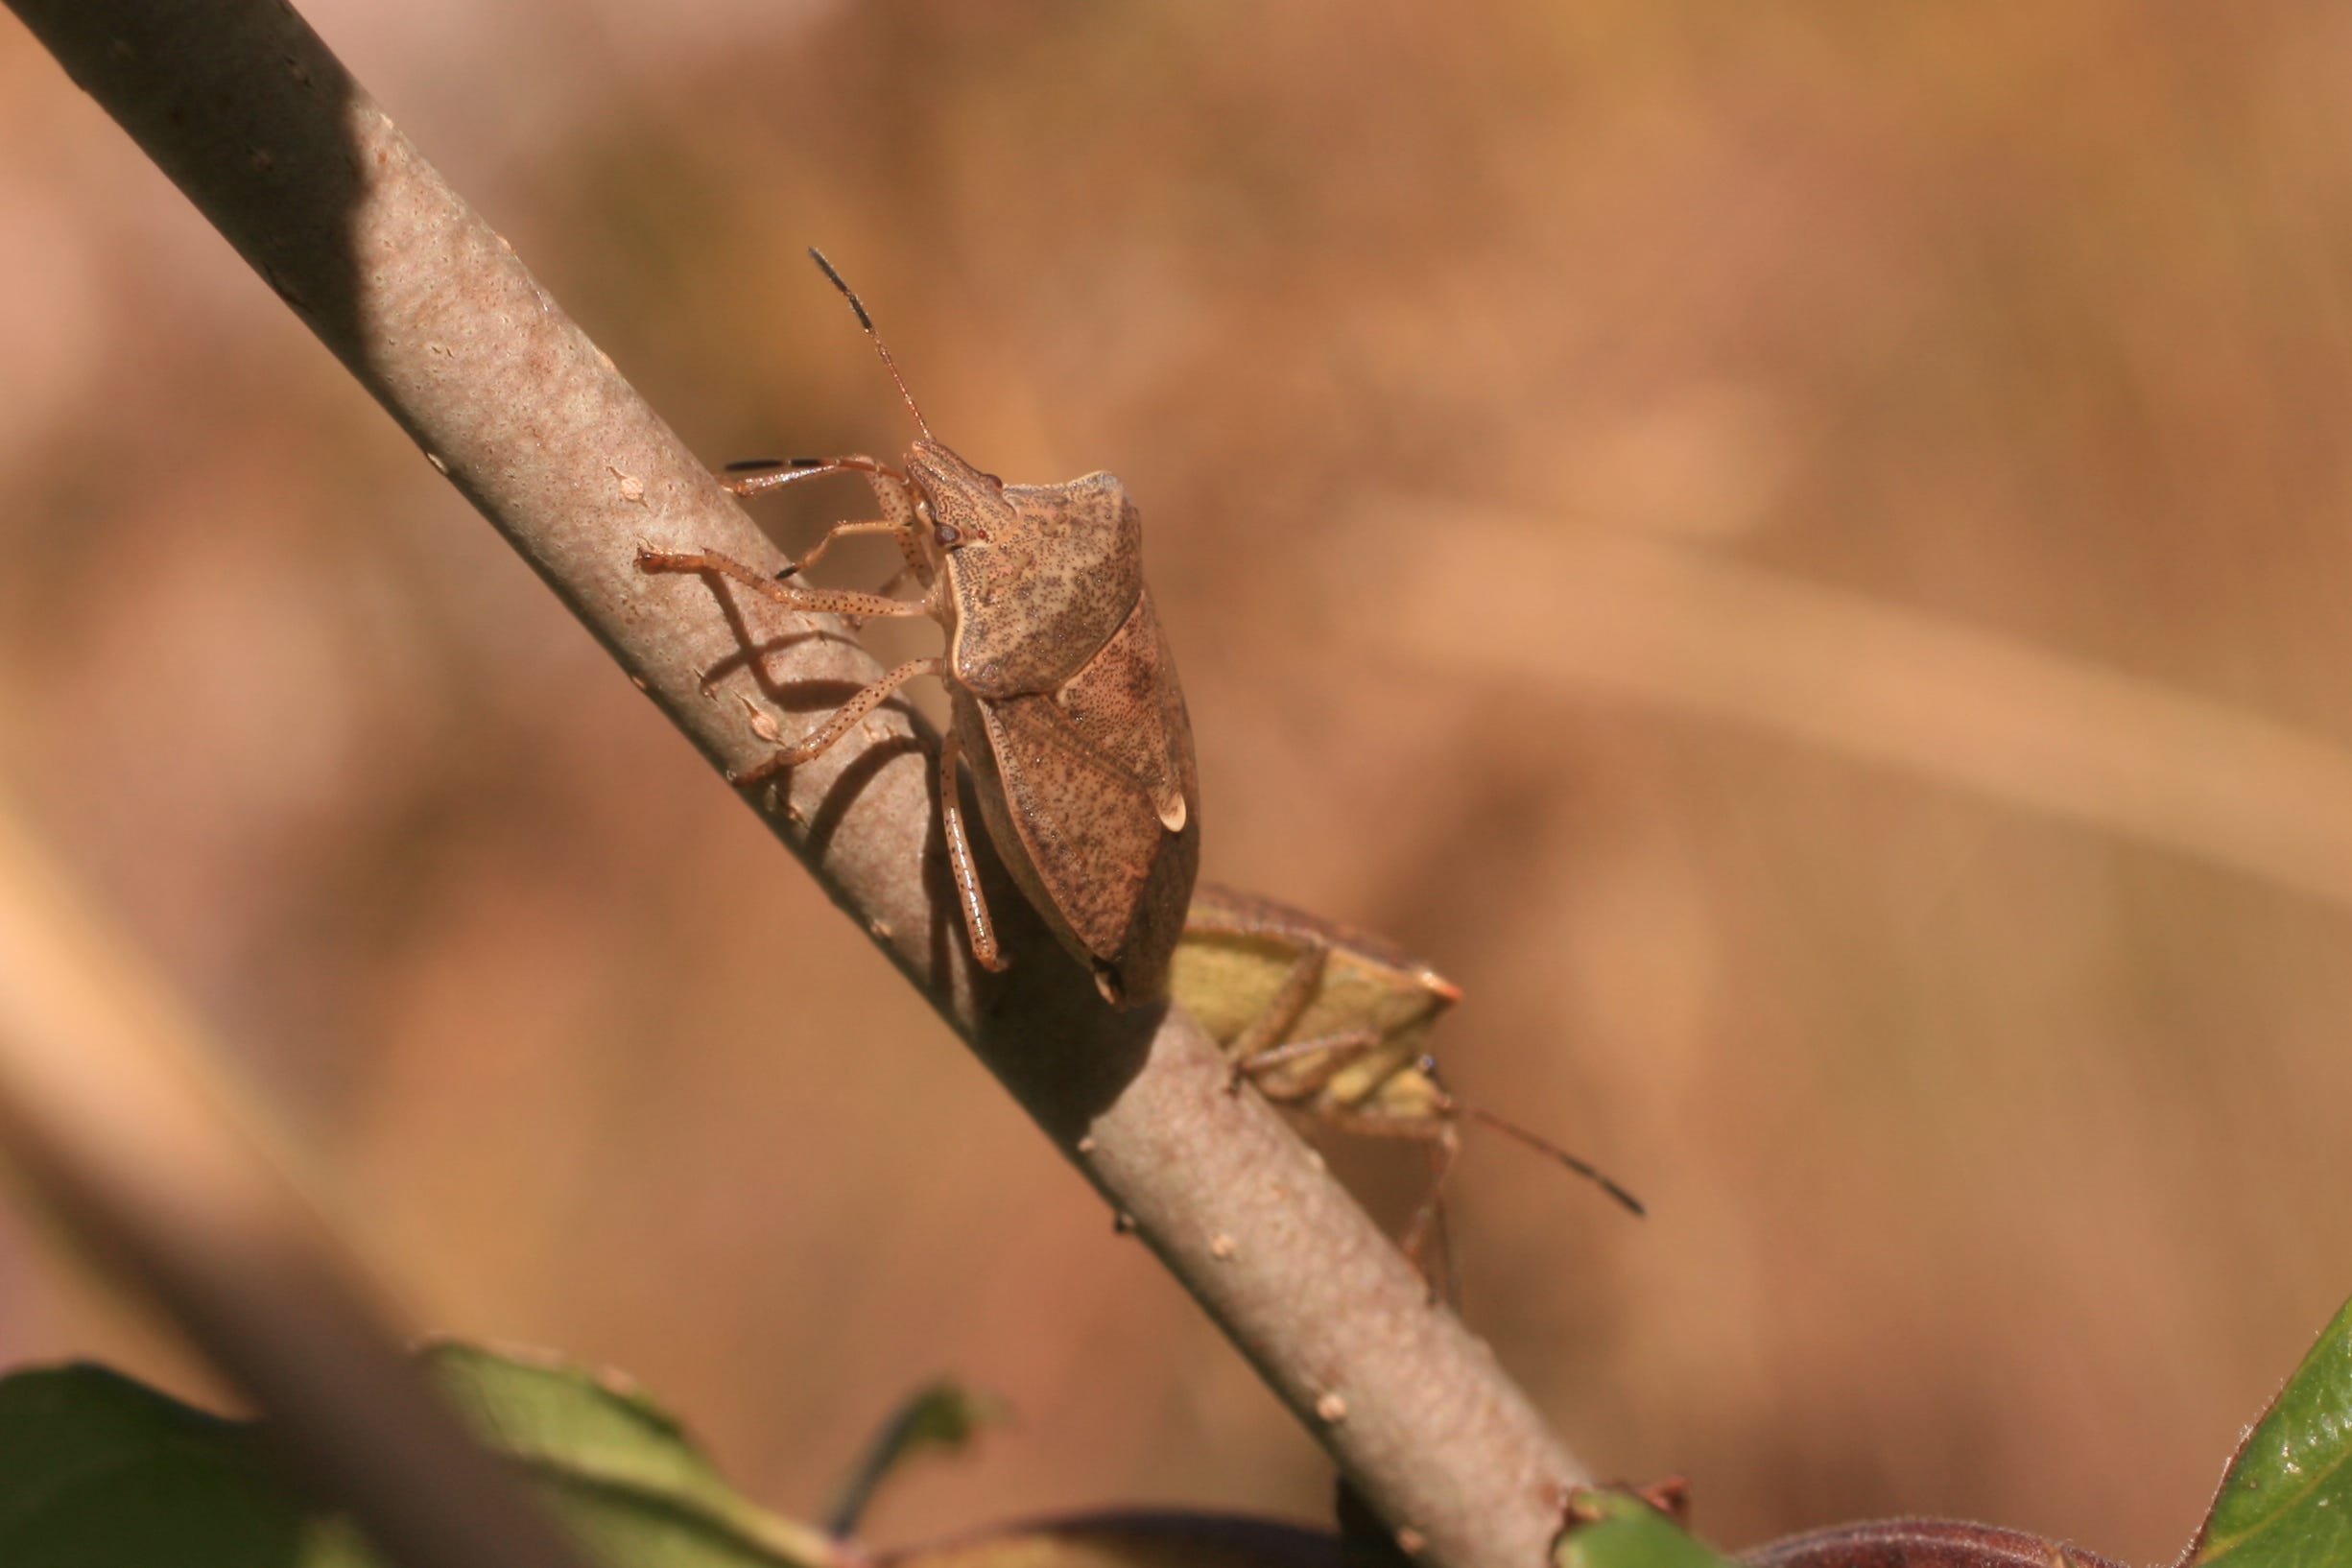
[0,0,2352,1561]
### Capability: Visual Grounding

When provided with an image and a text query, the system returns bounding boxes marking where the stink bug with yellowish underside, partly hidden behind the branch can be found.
[1169,882,1642,1297]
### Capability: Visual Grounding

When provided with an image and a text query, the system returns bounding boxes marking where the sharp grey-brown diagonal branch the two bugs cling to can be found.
[10,0,1580,1568]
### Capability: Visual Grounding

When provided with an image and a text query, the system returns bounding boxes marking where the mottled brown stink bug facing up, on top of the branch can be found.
[637,249,1200,1007]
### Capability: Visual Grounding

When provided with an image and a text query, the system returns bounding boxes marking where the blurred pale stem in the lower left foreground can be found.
[0,790,581,1568]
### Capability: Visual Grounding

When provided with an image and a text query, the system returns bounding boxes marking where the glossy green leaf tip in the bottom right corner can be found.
[2187,1302,2352,1568]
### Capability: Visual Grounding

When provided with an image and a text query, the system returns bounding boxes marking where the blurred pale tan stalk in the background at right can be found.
[1354,498,2352,908]
